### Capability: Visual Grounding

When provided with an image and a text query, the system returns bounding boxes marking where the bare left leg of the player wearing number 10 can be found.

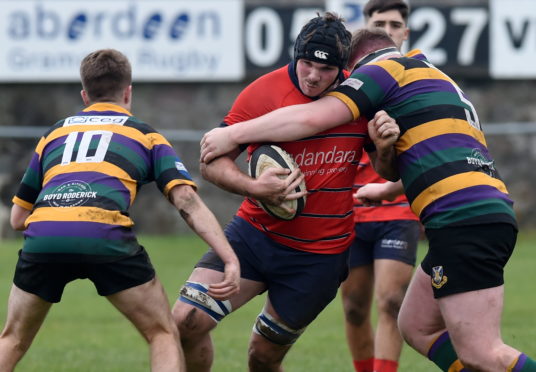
[0,285,52,372]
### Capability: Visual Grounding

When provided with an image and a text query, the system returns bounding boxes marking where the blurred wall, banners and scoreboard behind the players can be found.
[0,0,536,237]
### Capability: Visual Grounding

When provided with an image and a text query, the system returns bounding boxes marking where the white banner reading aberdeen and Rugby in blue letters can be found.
[0,0,245,82]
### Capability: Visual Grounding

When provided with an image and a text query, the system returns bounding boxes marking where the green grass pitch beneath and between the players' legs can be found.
[0,233,536,372]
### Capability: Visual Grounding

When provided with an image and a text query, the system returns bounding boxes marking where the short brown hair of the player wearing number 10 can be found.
[80,49,132,102]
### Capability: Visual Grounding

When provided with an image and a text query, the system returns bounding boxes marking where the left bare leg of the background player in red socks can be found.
[341,265,374,360]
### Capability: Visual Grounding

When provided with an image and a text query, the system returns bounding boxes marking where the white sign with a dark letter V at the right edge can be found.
[490,0,536,79]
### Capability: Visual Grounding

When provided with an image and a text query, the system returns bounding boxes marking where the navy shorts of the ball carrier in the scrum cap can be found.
[196,216,348,329]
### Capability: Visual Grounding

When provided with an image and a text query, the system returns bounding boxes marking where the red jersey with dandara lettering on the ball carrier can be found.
[224,65,369,254]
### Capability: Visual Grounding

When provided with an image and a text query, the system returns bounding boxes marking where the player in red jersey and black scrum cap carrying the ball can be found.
[173,13,368,371]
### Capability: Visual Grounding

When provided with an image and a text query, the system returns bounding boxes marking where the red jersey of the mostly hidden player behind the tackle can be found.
[354,152,419,223]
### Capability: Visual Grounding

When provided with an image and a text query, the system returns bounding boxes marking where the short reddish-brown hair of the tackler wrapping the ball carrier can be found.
[350,27,396,67]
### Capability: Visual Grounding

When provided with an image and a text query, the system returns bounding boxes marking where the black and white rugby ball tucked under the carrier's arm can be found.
[249,145,306,221]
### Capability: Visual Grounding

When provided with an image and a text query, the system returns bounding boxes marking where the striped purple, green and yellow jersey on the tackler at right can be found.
[328,52,516,228]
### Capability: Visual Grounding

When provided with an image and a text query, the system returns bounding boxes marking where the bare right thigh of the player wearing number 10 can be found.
[106,277,175,337]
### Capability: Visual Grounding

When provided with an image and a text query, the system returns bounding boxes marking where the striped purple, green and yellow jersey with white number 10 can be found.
[13,103,196,262]
